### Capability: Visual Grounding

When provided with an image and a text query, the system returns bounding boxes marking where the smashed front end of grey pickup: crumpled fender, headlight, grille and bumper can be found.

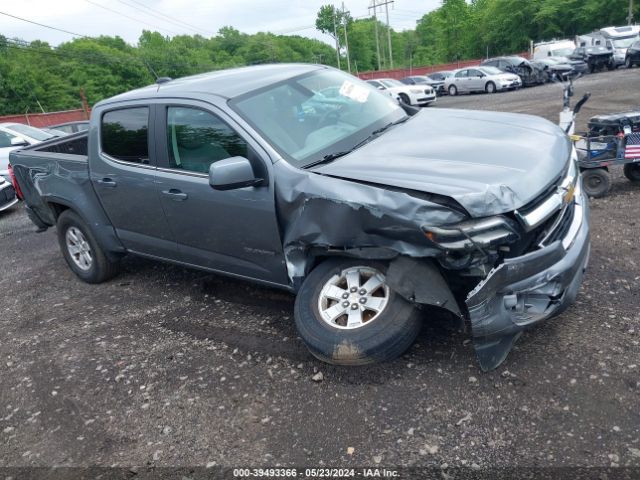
[276,146,589,370]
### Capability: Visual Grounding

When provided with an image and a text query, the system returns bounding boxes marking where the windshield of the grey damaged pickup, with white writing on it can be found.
[230,70,407,167]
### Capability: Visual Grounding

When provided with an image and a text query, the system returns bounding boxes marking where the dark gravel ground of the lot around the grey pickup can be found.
[0,69,640,476]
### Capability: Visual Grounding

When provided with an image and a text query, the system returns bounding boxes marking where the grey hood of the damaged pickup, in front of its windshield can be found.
[314,108,571,217]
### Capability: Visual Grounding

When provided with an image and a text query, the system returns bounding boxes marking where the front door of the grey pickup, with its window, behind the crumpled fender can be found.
[156,100,288,285]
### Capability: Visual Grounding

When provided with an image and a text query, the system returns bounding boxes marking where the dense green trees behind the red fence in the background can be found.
[0,0,640,115]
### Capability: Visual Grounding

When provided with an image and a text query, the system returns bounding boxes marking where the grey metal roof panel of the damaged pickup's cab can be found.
[99,63,330,105]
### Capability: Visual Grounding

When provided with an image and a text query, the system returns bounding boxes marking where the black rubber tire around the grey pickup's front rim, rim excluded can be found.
[294,259,422,365]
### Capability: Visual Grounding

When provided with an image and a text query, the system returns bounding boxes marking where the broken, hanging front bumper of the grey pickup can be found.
[466,182,590,371]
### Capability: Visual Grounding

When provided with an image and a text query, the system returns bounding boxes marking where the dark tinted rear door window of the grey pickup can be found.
[100,107,149,165]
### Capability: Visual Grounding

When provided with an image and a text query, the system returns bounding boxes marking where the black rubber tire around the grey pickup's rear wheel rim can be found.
[56,210,119,283]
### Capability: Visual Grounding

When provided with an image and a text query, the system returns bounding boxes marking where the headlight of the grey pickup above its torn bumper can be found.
[422,216,520,250]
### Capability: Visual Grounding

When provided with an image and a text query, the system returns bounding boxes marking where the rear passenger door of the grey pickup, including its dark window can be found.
[89,104,177,259]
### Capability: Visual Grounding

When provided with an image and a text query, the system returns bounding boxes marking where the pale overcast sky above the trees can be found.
[0,0,441,45]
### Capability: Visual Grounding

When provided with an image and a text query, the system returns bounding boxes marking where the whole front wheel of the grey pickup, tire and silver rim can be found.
[294,259,422,365]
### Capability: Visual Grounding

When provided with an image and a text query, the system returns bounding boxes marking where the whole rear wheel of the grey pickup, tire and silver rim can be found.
[56,210,119,283]
